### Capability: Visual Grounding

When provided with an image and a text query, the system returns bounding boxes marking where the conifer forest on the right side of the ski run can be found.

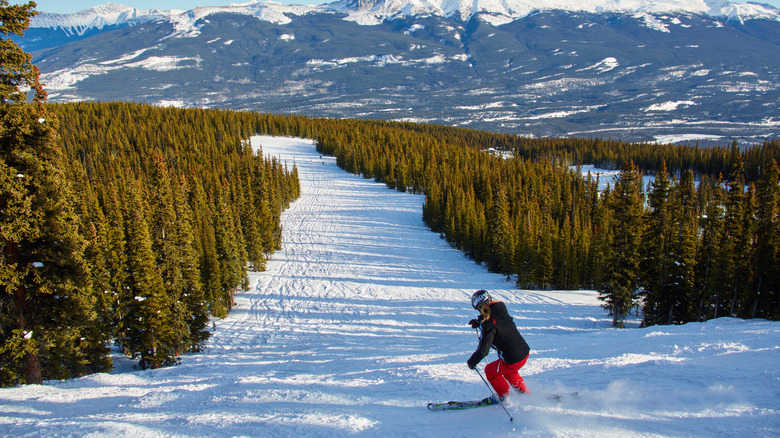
[310,118,780,325]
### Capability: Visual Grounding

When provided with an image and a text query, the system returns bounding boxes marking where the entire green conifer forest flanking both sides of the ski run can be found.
[0,0,780,386]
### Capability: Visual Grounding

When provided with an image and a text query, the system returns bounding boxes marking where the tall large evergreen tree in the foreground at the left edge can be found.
[0,0,94,385]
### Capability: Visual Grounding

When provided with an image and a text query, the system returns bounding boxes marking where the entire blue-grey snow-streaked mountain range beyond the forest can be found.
[18,0,780,144]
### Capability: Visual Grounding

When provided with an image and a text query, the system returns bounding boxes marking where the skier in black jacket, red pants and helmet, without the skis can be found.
[466,290,531,399]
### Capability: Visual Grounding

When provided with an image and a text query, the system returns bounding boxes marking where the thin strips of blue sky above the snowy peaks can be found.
[21,0,780,13]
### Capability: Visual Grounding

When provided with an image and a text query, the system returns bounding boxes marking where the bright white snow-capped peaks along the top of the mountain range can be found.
[31,0,780,34]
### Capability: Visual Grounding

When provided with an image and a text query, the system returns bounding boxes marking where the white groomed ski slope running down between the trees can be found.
[0,137,780,437]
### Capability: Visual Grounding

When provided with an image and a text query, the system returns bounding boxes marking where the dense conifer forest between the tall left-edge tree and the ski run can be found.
[54,103,299,367]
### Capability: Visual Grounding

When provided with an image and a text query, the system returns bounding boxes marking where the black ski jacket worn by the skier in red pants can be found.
[468,301,531,366]
